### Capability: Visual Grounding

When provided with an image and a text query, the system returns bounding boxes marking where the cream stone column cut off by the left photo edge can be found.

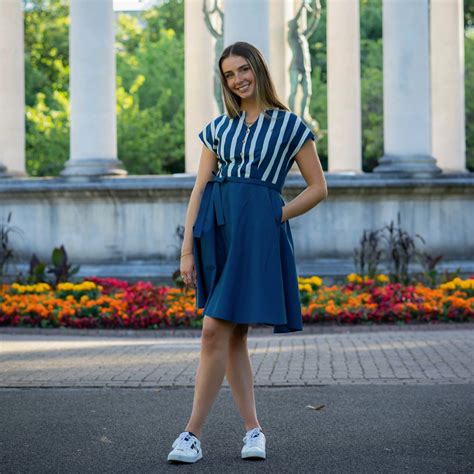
[0,0,26,178]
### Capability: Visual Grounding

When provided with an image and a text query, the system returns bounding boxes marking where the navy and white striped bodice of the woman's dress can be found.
[199,109,314,188]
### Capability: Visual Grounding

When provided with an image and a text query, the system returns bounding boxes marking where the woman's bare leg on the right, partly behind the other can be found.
[226,324,260,431]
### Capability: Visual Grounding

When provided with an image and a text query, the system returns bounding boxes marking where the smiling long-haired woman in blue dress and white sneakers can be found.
[168,42,327,463]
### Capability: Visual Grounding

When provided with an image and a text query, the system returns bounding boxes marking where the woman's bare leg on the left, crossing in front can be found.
[185,316,236,438]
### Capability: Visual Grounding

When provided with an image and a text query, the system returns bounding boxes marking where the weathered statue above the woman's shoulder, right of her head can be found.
[288,0,321,135]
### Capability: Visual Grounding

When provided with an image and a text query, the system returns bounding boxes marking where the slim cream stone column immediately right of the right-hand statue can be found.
[327,0,362,174]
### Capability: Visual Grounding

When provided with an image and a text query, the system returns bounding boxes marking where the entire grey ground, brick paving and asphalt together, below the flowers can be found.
[0,324,474,474]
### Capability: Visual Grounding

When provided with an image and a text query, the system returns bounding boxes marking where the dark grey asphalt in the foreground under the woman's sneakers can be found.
[0,384,474,474]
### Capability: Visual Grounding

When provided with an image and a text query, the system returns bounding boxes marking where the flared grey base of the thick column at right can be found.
[372,155,442,178]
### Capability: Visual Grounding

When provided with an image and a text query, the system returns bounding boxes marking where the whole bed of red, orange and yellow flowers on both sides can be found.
[0,274,474,329]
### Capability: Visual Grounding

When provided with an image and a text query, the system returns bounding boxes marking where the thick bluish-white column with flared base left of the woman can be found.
[61,0,126,177]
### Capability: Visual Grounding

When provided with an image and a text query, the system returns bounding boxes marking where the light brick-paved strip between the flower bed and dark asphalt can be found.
[0,328,474,387]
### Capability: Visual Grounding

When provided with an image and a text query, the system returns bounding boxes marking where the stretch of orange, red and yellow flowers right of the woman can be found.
[300,274,474,324]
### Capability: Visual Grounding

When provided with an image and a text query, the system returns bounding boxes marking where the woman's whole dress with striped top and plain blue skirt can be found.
[193,109,315,333]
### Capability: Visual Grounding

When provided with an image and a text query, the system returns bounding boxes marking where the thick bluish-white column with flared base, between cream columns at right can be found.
[374,0,441,177]
